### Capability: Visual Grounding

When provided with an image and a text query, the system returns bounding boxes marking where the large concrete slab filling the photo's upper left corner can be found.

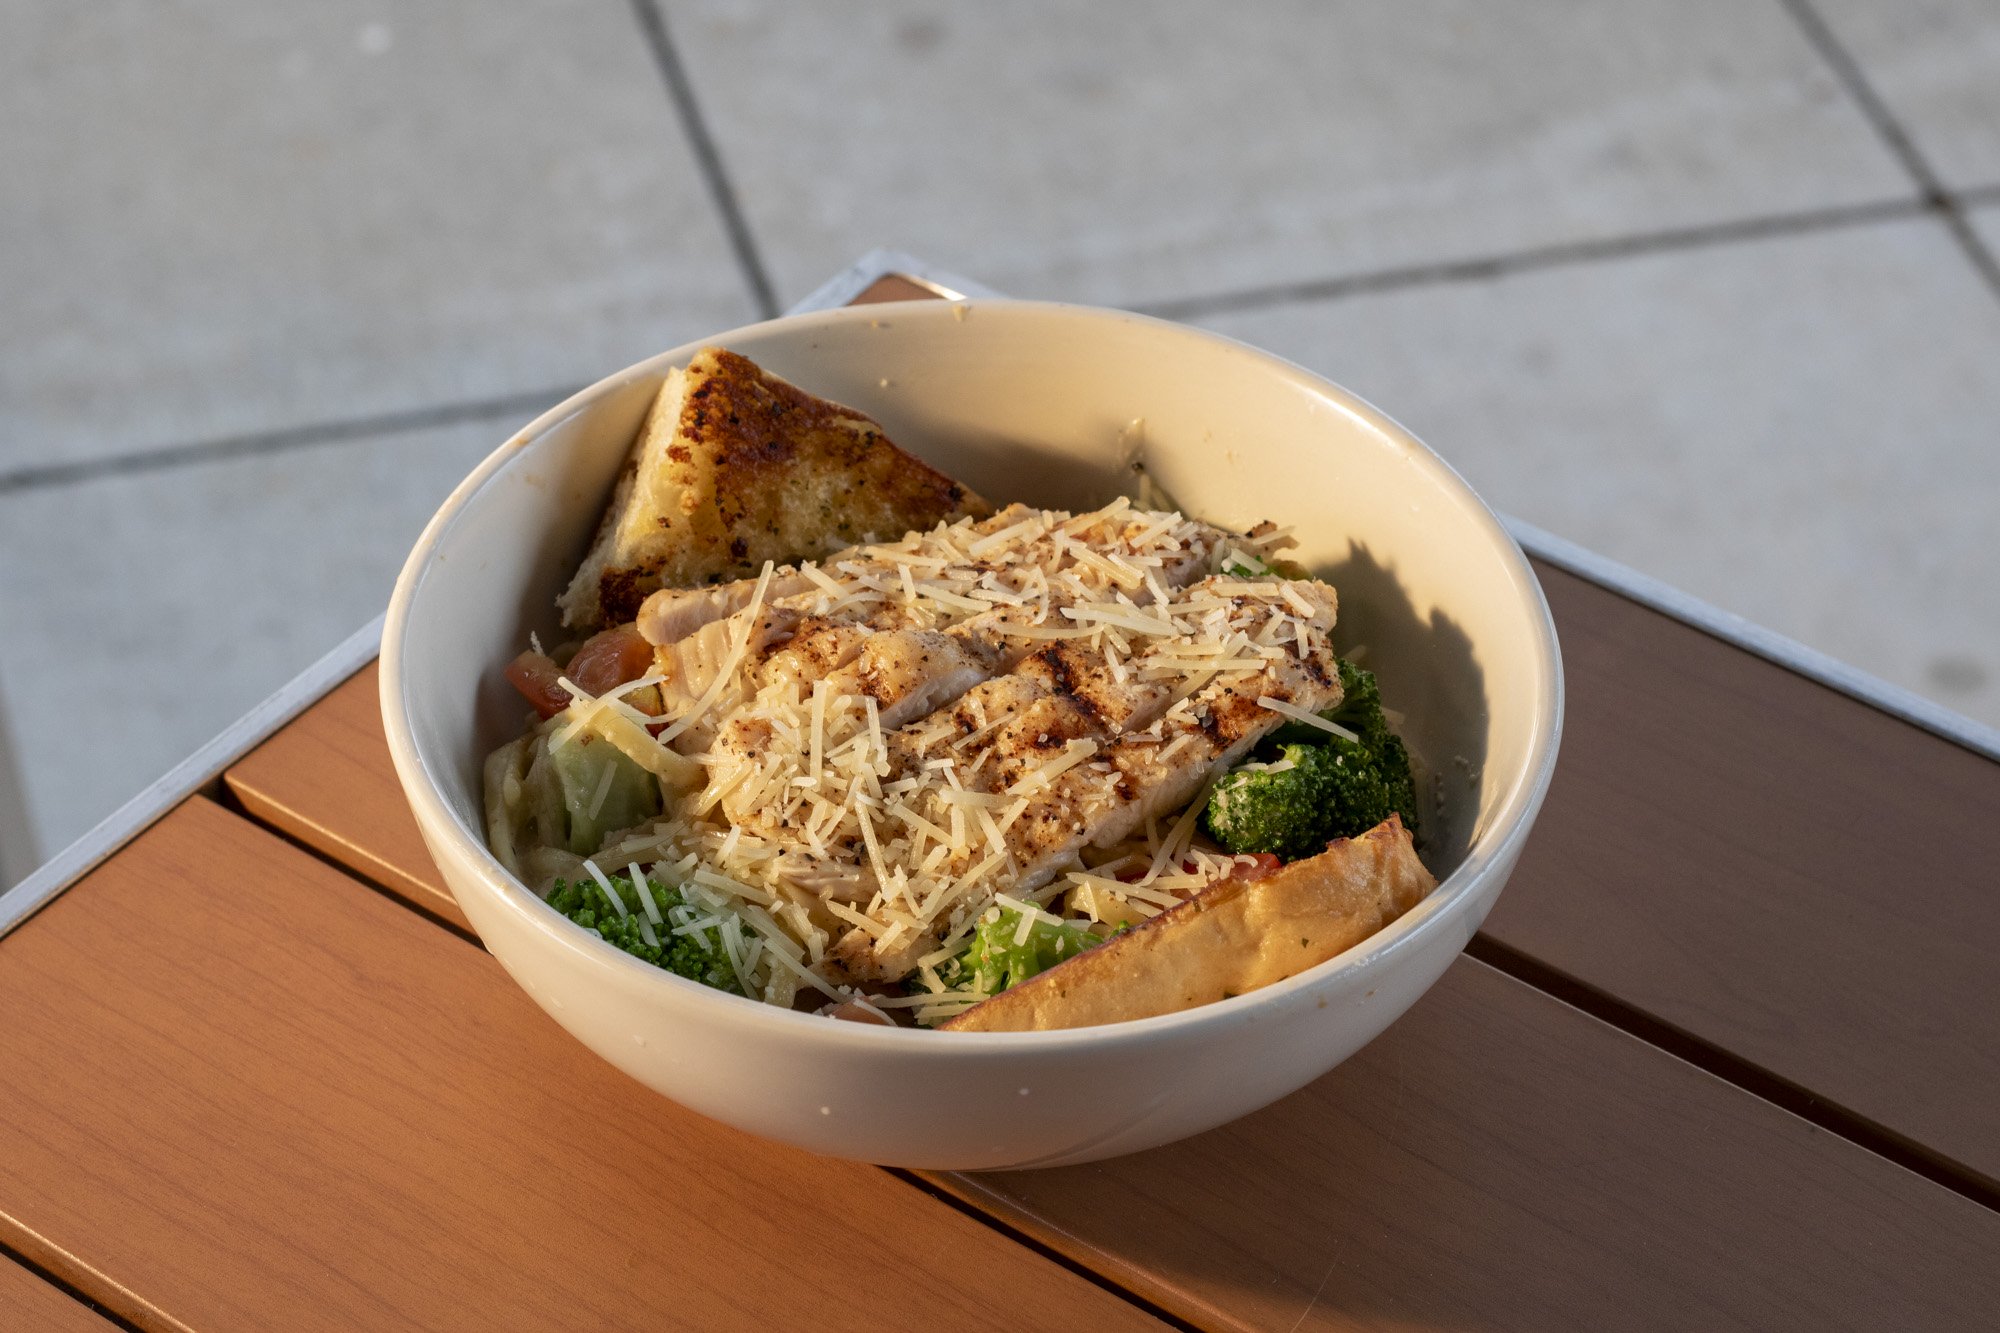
[0,0,756,472]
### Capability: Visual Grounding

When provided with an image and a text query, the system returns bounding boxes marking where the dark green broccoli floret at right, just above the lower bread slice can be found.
[1202,660,1416,861]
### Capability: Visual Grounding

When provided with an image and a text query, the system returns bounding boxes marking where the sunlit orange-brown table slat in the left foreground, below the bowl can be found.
[0,799,1158,1329]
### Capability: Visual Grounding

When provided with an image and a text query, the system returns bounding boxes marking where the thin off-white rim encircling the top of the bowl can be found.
[380,298,1564,1061]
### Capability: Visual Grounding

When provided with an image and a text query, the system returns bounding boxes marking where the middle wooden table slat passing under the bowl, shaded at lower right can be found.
[230,673,2000,1327]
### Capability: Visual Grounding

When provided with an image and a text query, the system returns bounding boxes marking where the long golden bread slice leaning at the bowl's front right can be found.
[942,815,1438,1033]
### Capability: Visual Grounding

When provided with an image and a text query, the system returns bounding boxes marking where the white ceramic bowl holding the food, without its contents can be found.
[382,302,1562,1169]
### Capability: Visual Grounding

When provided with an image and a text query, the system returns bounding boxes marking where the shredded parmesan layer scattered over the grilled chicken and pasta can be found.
[540,500,1334,1008]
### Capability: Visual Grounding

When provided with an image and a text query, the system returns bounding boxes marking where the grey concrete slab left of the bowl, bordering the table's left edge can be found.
[0,410,522,857]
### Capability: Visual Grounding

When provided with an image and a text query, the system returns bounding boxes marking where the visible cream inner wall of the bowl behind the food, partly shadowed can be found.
[384,302,1562,1040]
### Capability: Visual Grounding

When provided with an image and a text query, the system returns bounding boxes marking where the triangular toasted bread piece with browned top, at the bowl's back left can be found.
[560,348,990,628]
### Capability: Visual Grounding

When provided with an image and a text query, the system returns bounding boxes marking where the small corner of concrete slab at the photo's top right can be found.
[1814,0,2000,190]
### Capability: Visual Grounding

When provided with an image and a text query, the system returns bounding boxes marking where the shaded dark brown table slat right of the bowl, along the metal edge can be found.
[1484,566,2000,1193]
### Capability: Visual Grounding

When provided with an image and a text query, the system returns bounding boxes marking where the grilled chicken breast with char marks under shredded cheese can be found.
[620,496,1338,981]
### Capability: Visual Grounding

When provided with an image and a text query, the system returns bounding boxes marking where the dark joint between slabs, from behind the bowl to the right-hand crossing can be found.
[1138,198,1932,318]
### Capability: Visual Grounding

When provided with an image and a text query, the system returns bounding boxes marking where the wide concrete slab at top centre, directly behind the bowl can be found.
[670,0,1908,304]
